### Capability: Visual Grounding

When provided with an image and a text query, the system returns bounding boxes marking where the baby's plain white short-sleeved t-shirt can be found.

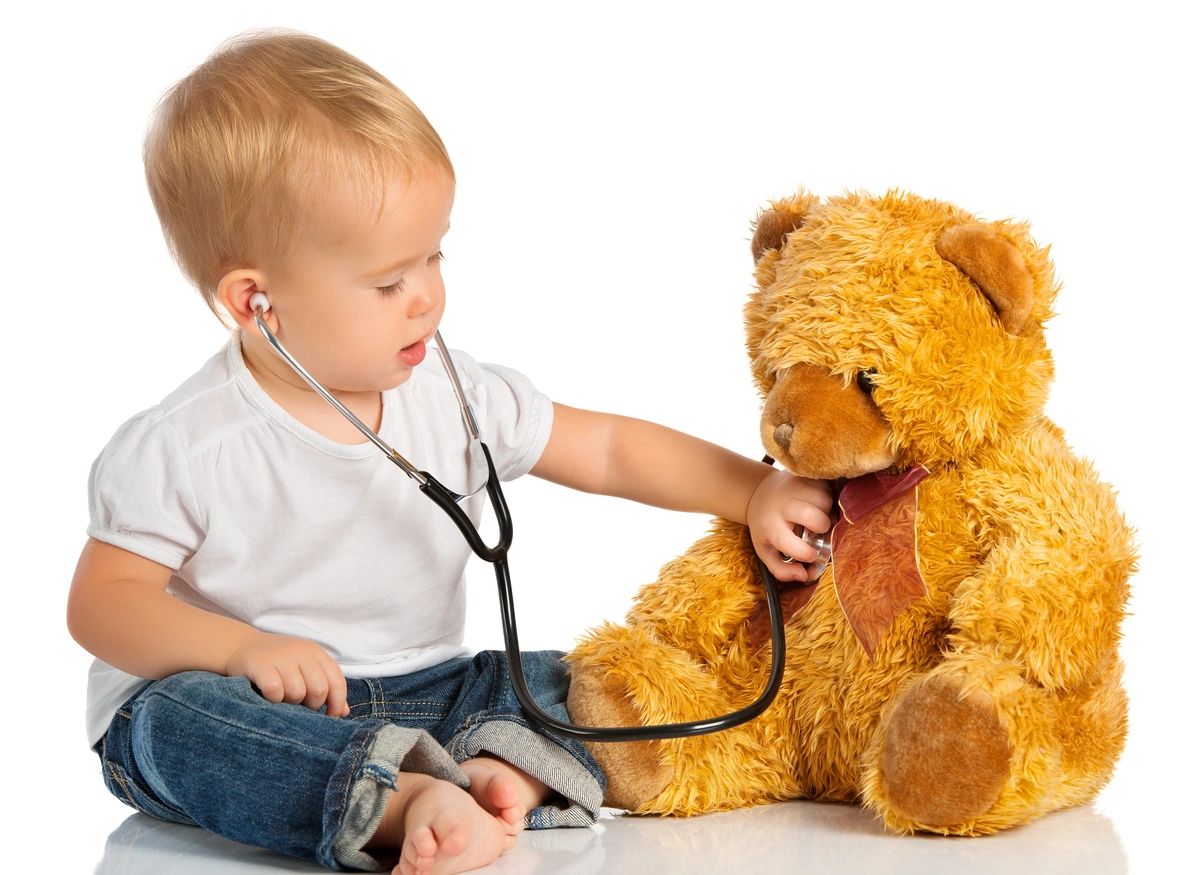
[88,333,553,746]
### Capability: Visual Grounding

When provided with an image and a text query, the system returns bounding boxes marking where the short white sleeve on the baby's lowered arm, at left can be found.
[88,411,204,571]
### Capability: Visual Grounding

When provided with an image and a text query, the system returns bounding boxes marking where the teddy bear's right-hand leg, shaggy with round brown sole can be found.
[862,656,1079,835]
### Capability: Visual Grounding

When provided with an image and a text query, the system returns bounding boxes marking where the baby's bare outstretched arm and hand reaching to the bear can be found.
[532,404,832,580]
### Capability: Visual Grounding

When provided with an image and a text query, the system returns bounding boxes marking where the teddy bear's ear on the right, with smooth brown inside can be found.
[936,222,1034,334]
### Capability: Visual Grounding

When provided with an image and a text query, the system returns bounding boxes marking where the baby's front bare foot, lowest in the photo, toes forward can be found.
[366,774,516,875]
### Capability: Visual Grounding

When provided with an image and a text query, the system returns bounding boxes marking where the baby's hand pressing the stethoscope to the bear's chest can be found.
[746,471,832,581]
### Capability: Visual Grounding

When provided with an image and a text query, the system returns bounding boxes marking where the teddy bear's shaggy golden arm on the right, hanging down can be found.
[948,445,1135,689]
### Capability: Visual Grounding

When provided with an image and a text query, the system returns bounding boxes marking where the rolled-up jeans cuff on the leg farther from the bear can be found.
[319,723,470,871]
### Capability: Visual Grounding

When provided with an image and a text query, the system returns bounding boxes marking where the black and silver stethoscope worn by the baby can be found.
[249,291,829,742]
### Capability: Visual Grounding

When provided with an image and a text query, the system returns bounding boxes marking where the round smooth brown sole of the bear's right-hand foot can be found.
[880,676,1011,833]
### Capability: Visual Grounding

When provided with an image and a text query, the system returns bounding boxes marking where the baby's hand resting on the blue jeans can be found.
[225,632,350,717]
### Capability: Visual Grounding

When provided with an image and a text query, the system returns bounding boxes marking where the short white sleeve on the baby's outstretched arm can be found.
[471,354,554,481]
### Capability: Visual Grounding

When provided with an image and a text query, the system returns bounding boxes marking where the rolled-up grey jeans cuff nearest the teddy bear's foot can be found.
[448,716,603,829]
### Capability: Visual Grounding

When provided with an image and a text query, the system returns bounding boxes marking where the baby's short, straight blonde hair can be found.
[143,31,453,327]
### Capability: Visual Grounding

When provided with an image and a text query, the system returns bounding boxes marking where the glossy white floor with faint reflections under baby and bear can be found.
[96,802,1128,875]
